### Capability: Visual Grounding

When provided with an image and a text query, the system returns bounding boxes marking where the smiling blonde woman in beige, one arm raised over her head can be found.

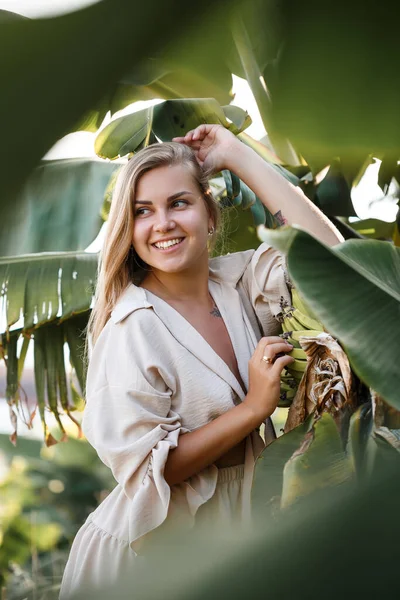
[61,125,341,598]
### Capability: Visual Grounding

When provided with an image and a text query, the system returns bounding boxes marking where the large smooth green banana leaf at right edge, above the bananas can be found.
[258,227,400,408]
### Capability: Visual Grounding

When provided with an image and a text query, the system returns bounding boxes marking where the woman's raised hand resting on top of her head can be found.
[172,125,243,173]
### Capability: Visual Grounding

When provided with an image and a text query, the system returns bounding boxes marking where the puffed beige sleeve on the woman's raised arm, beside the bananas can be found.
[241,243,291,335]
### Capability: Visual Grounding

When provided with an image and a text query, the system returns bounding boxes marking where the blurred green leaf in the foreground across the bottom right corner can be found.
[70,458,400,600]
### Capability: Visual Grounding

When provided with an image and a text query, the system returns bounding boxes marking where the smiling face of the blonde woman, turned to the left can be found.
[132,165,213,273]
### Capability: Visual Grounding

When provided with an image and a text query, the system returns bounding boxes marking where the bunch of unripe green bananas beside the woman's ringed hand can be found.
[278,288,324,408]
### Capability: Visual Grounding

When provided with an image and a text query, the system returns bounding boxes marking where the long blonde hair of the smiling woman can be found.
[88,142,220,344]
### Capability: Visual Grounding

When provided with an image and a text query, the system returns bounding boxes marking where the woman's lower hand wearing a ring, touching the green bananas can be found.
[244,336,294,423]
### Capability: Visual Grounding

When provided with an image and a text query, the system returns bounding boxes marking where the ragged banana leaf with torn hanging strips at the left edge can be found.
[0,252,97,445]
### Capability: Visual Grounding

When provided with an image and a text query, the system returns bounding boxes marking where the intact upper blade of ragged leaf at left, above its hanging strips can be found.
[0,252,98,333]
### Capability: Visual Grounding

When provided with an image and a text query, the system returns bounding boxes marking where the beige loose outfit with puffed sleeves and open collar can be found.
[60,244,290,598]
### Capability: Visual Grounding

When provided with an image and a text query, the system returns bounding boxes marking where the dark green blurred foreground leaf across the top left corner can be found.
[0,0,222,206]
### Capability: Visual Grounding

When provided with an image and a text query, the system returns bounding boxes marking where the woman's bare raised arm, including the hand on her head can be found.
[174,125,343,246]
